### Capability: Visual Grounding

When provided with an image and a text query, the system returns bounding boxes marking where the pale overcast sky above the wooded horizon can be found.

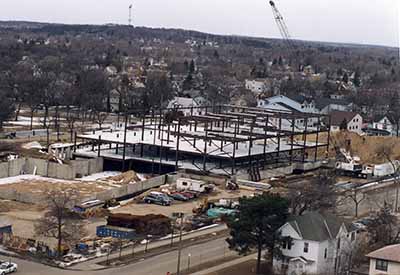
[0,0,400,46]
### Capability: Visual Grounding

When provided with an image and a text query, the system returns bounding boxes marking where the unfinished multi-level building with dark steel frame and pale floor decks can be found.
[74,105,330,180]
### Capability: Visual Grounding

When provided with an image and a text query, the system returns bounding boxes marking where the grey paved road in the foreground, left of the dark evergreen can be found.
[3,238,234,275]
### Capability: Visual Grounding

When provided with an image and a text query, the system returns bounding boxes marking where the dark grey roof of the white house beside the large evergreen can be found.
[288,212,346,242]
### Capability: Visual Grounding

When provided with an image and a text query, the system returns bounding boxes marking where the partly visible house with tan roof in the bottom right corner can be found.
[367,244,400,275]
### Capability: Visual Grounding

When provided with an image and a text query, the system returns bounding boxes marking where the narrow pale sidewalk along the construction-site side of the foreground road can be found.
[71,225,227,271]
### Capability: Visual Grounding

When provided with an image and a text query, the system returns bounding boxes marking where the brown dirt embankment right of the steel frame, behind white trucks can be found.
[330,132,400,164]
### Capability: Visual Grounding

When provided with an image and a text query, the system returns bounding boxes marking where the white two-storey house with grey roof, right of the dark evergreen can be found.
[273,212,357,275]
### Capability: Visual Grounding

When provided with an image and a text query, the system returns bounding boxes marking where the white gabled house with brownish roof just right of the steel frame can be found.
[331,111,363,135]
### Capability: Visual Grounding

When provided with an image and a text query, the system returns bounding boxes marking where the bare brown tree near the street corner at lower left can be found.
[35,190,86,256]
